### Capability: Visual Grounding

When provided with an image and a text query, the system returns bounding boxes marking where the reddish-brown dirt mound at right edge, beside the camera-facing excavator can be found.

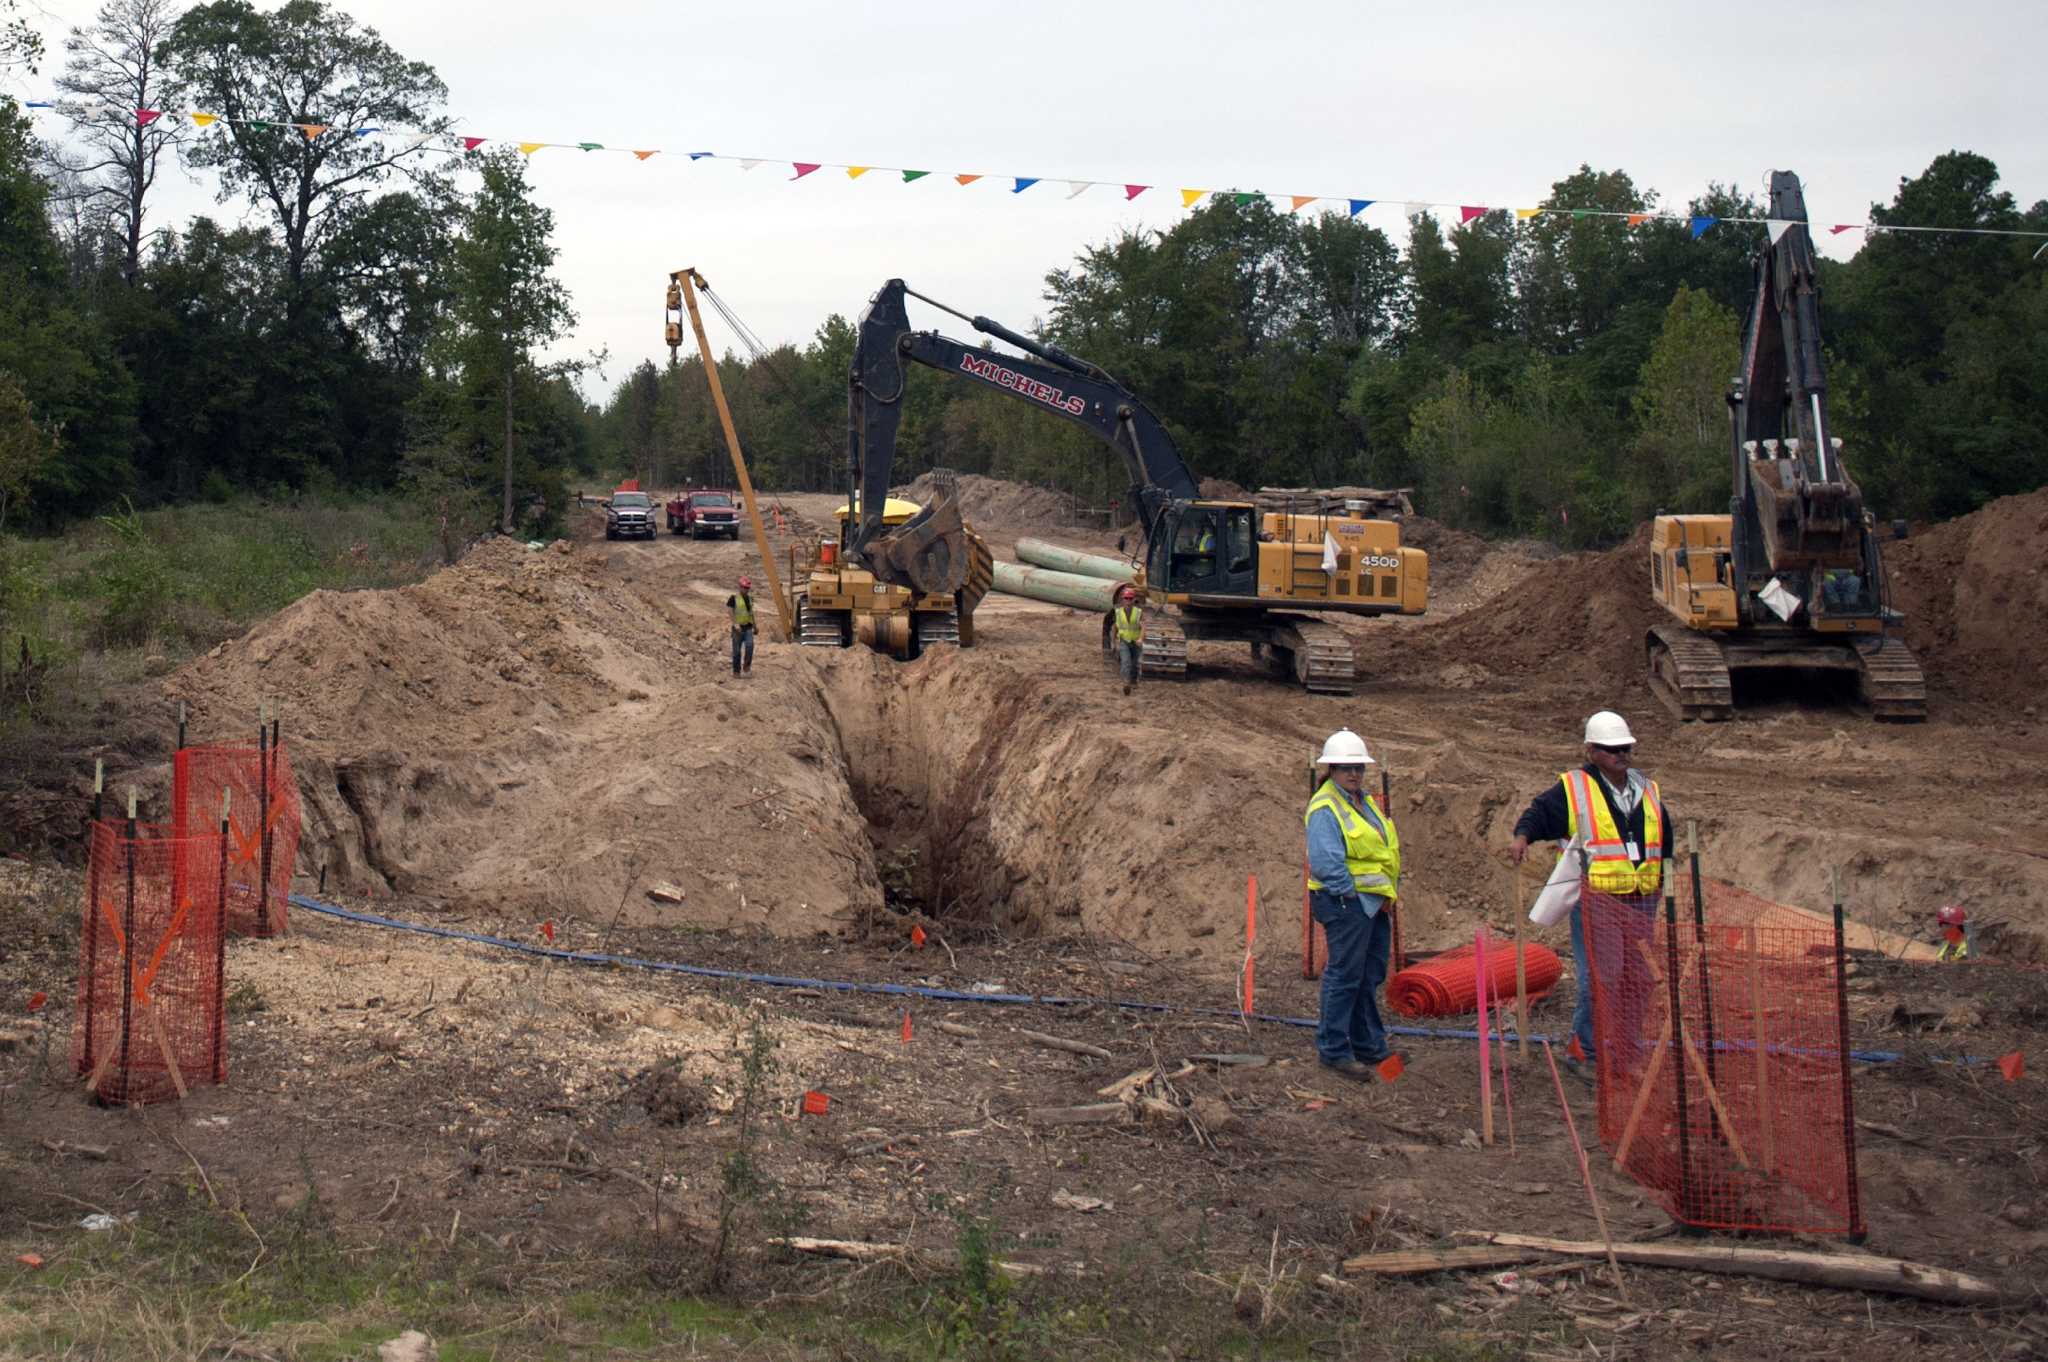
[1884,487,2048,700]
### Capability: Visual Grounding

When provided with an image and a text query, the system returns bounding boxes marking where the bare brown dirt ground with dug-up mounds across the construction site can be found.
[0,487,2048,1358]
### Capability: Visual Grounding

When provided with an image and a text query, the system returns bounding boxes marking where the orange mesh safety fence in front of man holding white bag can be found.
[1581,885,1864,1233]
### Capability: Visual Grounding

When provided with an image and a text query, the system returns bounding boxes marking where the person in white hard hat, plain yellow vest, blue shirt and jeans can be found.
[1300,729,1401,1083]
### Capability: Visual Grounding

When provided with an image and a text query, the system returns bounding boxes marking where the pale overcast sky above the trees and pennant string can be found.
[12,0,2048,399]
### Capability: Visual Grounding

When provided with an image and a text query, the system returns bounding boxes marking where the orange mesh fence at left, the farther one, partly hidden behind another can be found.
[170,746,299,936]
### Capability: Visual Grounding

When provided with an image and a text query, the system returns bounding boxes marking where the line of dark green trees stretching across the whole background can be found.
[0,0,2048,551]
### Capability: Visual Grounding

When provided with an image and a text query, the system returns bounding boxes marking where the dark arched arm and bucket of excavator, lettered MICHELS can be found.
[846,279,1200,590]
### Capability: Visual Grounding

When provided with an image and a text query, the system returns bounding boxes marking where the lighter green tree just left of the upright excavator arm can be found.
[1634,285,1743,518]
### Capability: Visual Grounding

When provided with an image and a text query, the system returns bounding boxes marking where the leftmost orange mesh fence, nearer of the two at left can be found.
[72,821,231,1102]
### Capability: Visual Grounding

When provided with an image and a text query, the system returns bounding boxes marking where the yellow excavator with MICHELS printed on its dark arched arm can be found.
[831,279,1430,694]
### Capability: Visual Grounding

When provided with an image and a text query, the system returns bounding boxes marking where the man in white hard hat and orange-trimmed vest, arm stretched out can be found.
[1507,709,1671,1081]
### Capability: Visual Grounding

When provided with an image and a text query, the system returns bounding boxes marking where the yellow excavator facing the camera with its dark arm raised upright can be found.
[1647,170,1927,721]
